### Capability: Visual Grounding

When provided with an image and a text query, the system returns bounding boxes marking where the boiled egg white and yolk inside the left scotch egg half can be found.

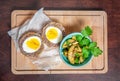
[22,36,41,53]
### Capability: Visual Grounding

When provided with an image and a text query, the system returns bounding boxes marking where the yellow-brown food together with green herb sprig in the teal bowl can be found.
[62,26,103,64]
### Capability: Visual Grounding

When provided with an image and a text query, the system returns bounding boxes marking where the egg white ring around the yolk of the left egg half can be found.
[22,36,41,53]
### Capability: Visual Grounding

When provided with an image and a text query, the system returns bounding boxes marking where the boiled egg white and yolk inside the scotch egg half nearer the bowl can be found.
[45,26,63,44]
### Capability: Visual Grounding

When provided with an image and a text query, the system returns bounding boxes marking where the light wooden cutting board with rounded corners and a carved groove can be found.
[11,10,108,74]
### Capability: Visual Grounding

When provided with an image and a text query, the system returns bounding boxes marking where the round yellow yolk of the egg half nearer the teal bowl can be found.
[46,28,58,40]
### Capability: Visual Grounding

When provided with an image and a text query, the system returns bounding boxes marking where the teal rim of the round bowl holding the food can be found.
[59,32,93,68]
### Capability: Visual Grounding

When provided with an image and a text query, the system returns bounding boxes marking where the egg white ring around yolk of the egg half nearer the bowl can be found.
[45,26,63,44]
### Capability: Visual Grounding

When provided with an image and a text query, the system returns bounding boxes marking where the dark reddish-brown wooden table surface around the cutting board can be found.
[0,0,120,81]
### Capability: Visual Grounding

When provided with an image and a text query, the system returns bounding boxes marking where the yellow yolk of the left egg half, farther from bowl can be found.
[26,38,40,50]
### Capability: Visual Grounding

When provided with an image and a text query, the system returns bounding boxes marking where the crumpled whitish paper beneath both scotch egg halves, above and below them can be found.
[8,8,61,70]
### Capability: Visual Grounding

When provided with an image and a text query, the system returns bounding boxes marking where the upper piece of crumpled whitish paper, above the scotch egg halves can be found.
[8,8,51,50]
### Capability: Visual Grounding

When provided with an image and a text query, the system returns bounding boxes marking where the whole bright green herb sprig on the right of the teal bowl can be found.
[76,26,103,58]
